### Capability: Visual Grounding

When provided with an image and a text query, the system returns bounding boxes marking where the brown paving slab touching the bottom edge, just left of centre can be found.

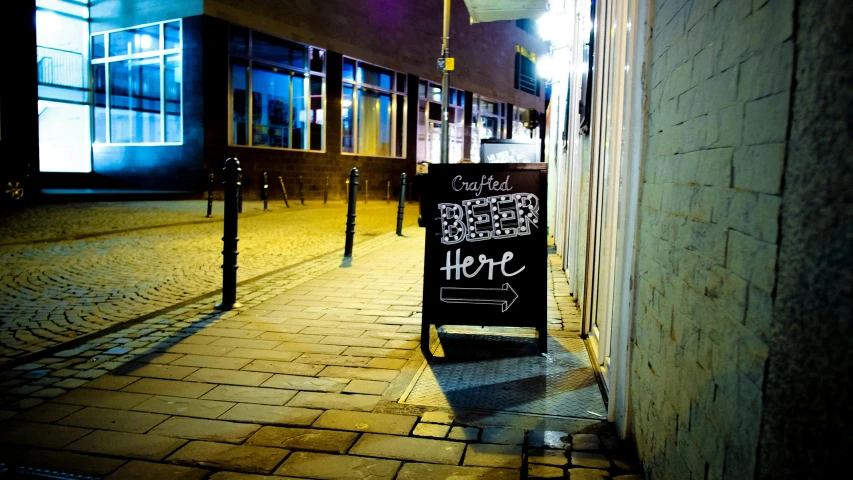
[275,452,400,480]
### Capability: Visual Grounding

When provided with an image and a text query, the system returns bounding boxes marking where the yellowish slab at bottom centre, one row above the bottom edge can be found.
[349,433,466,465]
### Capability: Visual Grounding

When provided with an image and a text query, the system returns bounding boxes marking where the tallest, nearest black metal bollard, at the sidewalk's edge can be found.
[216,158,241,310]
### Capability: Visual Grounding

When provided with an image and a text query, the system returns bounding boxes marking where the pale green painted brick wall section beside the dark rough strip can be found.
[631,0,794,479]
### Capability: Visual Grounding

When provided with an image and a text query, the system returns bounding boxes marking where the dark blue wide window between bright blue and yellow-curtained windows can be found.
[228,25,326,151]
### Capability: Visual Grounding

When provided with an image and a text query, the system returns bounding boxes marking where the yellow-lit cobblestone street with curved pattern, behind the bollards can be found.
[0,201,417,364]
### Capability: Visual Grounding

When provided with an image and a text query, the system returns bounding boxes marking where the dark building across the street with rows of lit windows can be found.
[26,0,545,198]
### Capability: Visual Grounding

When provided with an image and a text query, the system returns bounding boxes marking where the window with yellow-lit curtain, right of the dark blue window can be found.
[341,57,406,157]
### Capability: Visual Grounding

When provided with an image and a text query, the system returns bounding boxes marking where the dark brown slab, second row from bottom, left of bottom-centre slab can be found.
[246,427,358,454]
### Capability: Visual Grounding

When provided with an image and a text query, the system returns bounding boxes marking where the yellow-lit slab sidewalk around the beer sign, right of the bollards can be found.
[0,228,643,480]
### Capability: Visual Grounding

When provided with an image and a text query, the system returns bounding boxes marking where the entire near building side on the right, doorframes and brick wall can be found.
[546,0,853,479]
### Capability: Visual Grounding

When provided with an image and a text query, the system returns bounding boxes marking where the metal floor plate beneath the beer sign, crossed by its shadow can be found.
[400,327,607,420]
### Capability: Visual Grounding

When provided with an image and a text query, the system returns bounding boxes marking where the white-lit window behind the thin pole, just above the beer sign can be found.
[417,80,465,163]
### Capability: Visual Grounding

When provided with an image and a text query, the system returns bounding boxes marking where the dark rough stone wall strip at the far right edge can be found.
[756,0,853,479]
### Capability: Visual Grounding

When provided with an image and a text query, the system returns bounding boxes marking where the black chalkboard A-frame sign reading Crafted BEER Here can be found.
[421,163,548,355]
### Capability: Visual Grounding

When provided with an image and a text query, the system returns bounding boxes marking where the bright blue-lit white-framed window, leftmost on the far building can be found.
[91,20,183,145]
